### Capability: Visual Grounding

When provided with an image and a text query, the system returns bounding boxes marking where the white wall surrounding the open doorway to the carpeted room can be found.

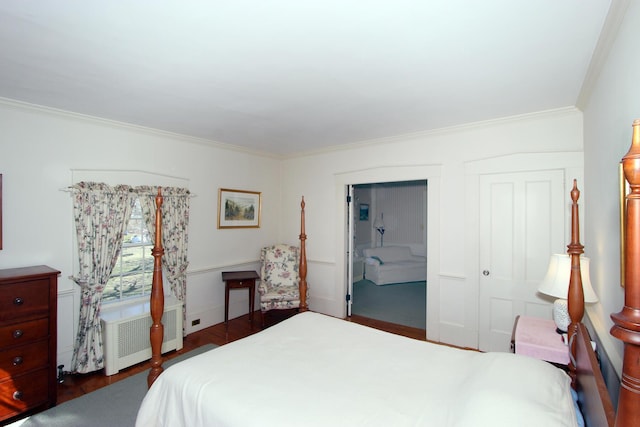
[282,109,582,344]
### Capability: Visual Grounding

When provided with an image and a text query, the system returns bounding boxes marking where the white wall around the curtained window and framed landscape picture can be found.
[0,102,282,369]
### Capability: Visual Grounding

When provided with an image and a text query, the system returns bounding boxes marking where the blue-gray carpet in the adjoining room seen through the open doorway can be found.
[351,279,427,329]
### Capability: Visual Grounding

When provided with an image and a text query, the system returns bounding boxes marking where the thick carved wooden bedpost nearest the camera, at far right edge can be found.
[611,119,640,426]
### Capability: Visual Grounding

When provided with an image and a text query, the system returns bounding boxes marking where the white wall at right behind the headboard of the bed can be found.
[583,1,640,375]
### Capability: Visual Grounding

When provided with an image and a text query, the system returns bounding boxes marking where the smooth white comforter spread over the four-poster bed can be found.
[136,312,577,427]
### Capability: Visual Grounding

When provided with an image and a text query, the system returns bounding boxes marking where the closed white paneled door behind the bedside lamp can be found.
[478,170,569,351]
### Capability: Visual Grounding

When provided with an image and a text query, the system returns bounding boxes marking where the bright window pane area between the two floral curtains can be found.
[102,199,153,303]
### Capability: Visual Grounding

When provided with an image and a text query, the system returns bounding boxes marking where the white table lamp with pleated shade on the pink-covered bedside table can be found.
[538,254,598,333]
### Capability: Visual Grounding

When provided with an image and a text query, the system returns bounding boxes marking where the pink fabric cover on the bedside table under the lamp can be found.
[515,316,569,365]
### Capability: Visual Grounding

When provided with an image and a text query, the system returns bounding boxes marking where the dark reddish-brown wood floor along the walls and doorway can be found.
[58,312,426,404]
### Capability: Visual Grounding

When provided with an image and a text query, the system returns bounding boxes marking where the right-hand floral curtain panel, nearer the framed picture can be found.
[136,186,190,334]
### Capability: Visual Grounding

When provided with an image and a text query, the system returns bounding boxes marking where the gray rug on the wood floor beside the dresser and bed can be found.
[10,344,217,427]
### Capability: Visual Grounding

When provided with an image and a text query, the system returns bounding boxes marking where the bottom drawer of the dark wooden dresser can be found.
[0,369,49,420]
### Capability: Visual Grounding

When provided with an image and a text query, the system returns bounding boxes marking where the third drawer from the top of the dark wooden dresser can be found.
[0,339,49,381]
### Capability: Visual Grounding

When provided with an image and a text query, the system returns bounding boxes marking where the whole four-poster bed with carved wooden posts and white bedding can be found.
[136,121,640,427]
